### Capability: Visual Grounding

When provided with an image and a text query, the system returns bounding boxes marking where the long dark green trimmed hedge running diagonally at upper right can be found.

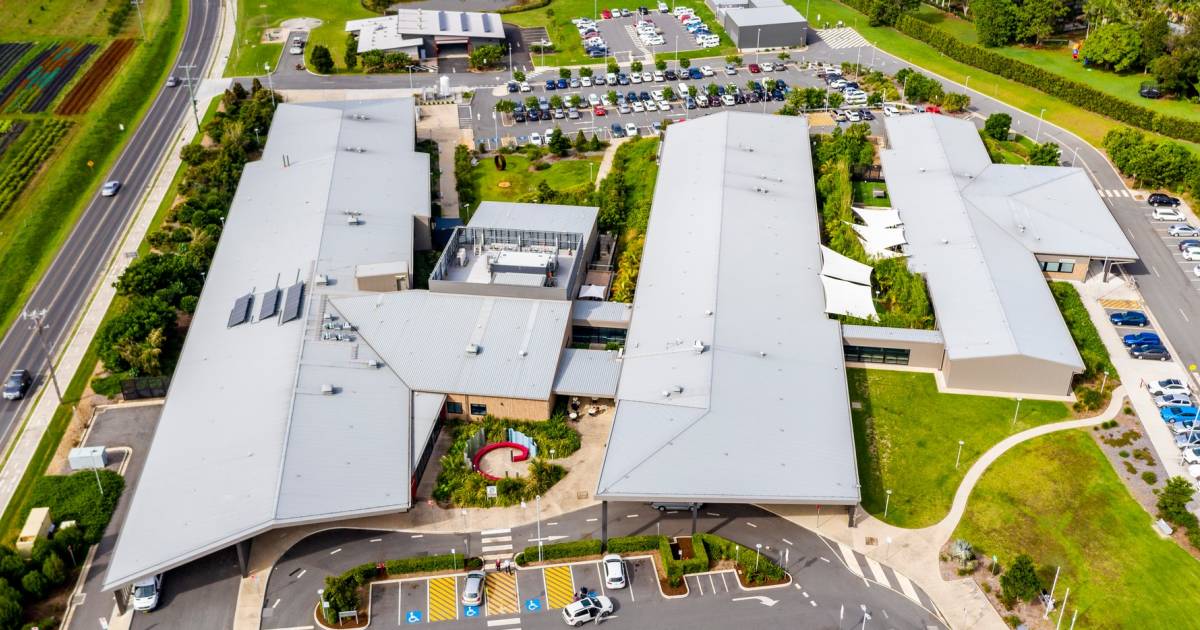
[840,0,1200,142]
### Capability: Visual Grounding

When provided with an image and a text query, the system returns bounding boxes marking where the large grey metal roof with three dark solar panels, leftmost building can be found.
[104,98,430,589]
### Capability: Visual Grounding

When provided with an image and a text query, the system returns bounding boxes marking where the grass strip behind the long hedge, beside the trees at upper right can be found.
[918,5,1200,125]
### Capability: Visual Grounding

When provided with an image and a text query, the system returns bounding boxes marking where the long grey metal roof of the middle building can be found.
[596,112,859,504]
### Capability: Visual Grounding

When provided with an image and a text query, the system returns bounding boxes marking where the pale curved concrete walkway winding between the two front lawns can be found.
[763,386,1126,630]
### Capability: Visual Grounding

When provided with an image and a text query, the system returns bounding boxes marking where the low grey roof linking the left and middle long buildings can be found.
[330,290,570,401]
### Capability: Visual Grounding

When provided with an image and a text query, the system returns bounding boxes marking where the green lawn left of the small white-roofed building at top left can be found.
[226,0,378,77]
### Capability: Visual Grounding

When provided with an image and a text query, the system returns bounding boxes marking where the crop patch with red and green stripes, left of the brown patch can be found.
[0,42,98,114]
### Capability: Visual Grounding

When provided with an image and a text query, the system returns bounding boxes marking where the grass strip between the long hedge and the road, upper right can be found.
[787,0,1200,154]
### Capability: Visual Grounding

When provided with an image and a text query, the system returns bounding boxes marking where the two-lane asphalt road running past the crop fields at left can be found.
[0,0,221,477]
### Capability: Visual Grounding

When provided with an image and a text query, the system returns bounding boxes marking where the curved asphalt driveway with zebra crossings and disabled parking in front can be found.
[263,503,943,630]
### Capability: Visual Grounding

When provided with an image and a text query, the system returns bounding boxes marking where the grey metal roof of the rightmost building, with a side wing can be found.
[881,115,1134,370]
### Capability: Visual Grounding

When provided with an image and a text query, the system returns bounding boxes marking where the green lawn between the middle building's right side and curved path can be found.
[846,368,1067,528]
